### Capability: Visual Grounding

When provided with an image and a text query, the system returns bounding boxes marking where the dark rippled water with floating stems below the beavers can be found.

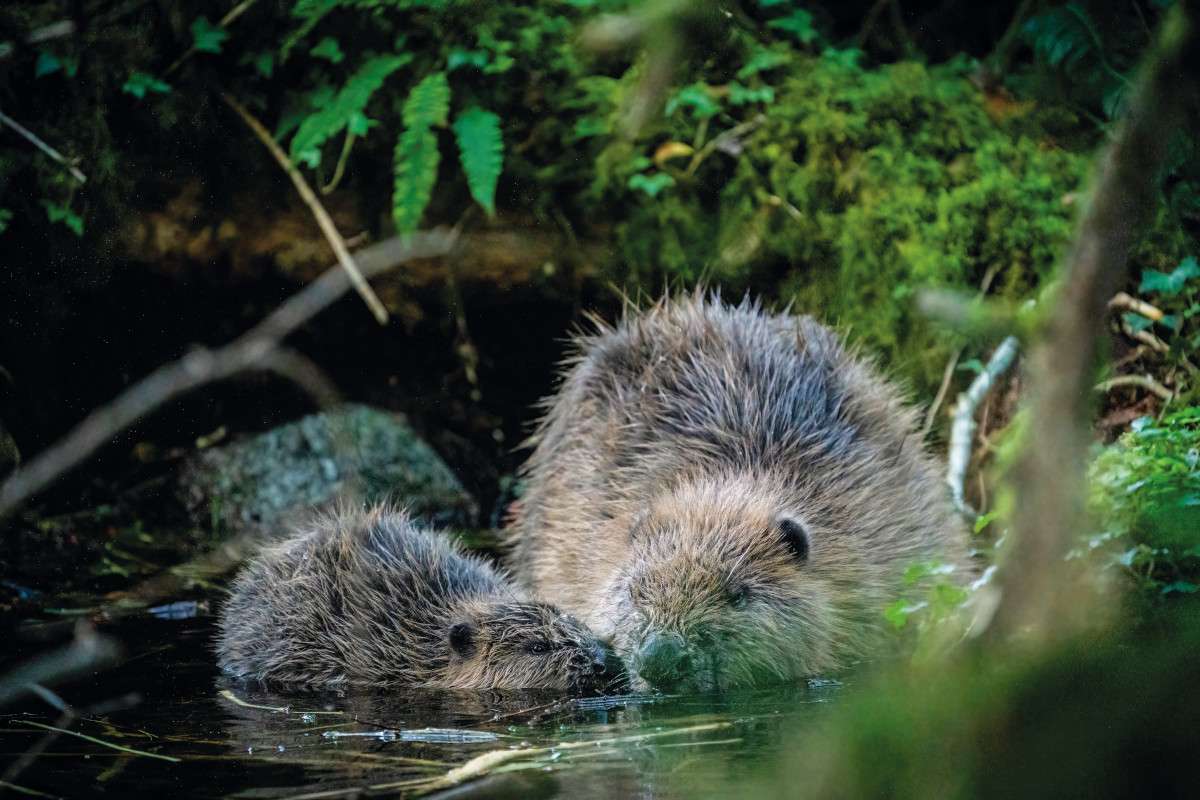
[0,619,844,800]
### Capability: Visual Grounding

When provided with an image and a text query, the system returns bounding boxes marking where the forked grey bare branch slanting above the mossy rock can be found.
[0,230,454,519]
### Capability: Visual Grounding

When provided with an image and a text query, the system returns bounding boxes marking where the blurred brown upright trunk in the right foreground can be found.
[992,2,1200,640]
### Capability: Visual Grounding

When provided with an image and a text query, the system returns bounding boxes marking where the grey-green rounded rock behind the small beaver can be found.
[179,405,479,531]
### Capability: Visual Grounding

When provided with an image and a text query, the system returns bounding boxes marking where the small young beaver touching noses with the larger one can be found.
[217,509,604,688]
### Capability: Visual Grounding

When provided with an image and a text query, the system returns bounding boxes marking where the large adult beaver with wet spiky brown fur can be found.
[512,295,966,688]
